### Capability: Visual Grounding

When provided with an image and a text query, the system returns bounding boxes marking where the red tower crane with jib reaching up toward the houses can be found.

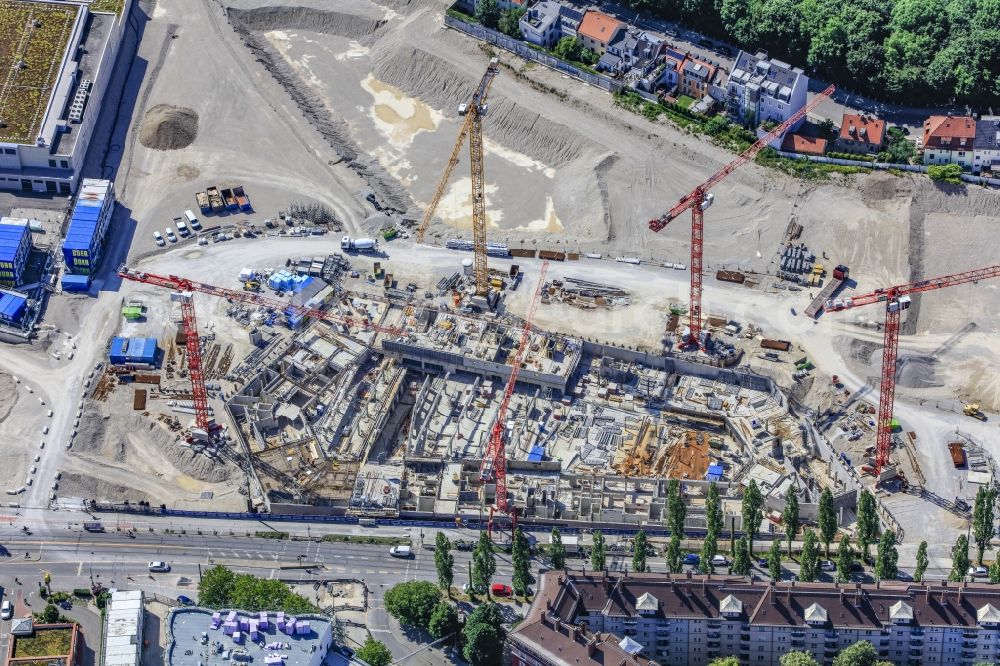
[649,86,836,345]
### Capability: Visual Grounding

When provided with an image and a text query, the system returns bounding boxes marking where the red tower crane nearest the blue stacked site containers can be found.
[118,264,405,432]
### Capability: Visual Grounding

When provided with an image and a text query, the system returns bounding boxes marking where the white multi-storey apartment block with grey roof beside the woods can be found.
[726,51,809,130]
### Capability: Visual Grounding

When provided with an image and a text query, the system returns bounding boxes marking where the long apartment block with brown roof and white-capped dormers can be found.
[508,571,1000,666]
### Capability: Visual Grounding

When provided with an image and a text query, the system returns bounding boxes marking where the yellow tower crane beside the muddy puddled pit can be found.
[417,58,500,296]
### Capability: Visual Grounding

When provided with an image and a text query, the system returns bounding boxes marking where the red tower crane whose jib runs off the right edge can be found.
[825,266,1000,479]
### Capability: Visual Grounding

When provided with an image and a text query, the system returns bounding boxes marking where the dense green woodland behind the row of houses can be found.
[628,0,1000,107]
